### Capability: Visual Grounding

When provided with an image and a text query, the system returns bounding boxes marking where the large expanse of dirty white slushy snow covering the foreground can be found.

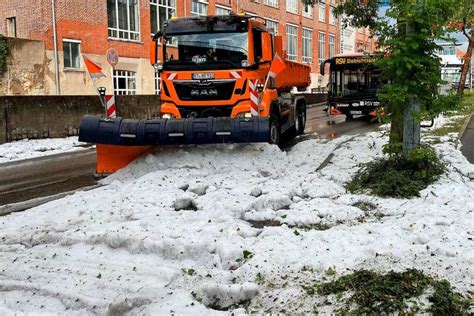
[0,132,474,315]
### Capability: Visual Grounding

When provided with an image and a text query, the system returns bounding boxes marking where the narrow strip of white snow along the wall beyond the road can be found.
[0,136,84,164]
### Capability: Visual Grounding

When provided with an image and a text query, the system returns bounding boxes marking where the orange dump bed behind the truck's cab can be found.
[275,60,311,90]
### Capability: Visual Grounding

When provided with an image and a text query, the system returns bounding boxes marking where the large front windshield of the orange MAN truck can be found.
[163,32,248,70]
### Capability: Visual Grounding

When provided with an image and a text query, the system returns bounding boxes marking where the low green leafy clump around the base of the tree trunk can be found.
[346,146,446,198]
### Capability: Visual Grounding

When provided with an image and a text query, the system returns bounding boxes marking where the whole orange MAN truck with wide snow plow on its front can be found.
[79,15,310,174]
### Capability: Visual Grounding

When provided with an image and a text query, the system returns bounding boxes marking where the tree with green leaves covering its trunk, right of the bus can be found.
[336,0,458,154]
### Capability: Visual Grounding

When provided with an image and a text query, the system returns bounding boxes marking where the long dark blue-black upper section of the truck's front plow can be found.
[79,115,270,146]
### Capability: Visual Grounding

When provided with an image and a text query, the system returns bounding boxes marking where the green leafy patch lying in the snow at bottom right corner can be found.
[304,269,471,315]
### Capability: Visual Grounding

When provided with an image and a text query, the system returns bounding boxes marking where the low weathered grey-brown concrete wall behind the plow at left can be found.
[0,95,160,143]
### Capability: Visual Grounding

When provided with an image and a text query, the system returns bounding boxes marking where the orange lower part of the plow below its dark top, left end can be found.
[94,144,153,179]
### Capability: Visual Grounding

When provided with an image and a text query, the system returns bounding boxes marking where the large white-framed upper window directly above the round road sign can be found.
[107,0,140,41]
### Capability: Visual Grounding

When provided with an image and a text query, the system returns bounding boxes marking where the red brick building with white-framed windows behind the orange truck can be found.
[0,0,375,95]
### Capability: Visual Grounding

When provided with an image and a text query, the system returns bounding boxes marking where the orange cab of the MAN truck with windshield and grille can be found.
[151,15,274,118]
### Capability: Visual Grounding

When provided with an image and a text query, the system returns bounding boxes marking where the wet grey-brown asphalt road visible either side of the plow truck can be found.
[0,106,377,206]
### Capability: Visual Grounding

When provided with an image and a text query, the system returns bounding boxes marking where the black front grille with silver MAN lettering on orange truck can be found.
[173,80,235,101]
